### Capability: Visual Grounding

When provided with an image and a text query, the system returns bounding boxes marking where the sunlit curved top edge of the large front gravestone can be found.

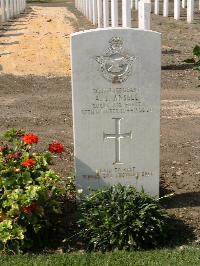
[70,27,162,38]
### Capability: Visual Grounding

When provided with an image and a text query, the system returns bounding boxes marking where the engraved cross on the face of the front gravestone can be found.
[103,118,132,164]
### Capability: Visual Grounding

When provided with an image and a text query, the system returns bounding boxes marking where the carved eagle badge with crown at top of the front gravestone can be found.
[96,37,135,83]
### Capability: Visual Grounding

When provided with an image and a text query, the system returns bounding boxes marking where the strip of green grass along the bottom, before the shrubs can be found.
[0,248,200,266]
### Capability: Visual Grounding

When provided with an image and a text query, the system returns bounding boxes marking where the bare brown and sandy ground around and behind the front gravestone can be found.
[0,0,200,246]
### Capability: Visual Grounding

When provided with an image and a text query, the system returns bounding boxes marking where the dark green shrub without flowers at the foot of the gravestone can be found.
[78,185,169,251]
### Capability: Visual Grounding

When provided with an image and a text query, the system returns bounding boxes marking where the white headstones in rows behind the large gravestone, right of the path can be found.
[75,0,200,29]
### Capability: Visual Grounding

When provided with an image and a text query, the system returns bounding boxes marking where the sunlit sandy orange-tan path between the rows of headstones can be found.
[0,3,76,76]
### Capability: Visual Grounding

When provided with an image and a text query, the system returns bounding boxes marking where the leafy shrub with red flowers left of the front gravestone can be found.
[0,129,72,253]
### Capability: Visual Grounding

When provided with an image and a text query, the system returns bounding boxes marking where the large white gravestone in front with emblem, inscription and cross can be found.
[71,28,161,195]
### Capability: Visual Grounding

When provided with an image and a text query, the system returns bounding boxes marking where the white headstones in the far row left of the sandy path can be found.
[0,0,26,22]
